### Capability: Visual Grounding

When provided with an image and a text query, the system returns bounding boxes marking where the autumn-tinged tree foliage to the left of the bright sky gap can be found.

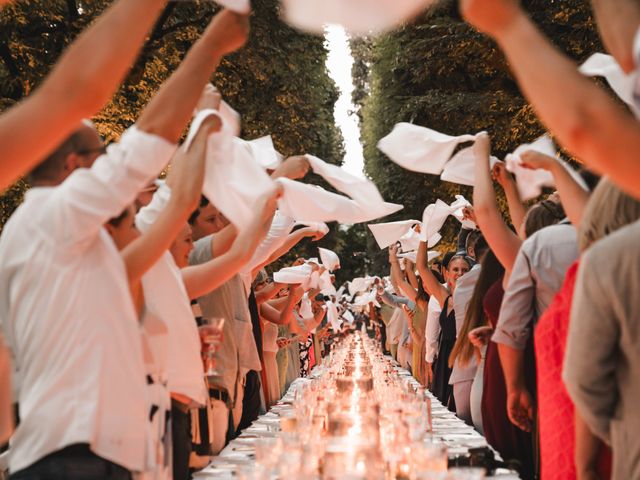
[0,0,343,253]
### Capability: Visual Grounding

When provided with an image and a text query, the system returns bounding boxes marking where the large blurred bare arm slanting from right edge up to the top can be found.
[460,0,640,197]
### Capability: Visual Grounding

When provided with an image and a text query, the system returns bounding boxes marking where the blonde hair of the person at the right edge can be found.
[578,178,640,252]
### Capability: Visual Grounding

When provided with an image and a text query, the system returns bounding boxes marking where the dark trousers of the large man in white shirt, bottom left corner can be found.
[9,444,131,480]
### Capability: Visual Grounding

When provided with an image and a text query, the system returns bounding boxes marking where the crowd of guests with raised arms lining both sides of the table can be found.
[0,0,640,480]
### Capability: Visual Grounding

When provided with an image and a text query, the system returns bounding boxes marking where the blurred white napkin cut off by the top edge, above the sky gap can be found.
[282,0,433,35]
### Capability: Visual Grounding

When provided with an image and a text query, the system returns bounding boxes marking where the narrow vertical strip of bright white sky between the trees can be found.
[325,25,364,177]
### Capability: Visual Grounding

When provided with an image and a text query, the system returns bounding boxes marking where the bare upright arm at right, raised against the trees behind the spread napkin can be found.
[473,133,522,272]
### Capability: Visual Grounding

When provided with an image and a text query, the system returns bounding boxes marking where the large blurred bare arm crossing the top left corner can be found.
[0,0,166,191]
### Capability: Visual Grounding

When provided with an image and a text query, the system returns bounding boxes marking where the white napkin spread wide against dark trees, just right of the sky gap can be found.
[378,122,475,175]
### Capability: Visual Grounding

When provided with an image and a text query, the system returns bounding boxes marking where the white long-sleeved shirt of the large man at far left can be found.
[0,127,175,472]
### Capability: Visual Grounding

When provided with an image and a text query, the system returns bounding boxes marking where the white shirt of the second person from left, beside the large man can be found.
[136,183,207,405]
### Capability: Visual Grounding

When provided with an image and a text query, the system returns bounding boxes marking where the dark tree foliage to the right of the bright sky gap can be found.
[354,0,602,271]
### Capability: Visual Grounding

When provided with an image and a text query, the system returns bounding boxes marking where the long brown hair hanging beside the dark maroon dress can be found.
[449,250,504,367]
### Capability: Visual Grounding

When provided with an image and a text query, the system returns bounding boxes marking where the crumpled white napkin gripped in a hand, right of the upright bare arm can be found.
[505,135,556,201]
